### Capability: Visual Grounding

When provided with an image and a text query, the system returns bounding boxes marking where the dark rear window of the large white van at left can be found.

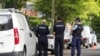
[0,15,13,31]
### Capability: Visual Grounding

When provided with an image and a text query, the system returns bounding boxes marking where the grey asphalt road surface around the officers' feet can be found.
[48,43,100,56]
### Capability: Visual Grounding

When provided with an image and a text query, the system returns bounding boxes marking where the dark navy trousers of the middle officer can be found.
[55,34,64,56]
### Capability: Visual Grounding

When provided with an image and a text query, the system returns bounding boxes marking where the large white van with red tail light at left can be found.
[0,9,37,56]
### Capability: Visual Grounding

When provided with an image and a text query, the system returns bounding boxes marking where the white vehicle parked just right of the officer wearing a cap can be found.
[82,26,97,48]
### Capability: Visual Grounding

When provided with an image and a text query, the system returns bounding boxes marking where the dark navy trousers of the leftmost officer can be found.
[38,35,48,56]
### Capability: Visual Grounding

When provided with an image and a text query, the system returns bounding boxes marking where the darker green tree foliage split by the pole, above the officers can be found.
[35,0,84,21]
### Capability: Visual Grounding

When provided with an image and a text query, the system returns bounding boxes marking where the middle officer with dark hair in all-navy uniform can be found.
[53,17,65,56]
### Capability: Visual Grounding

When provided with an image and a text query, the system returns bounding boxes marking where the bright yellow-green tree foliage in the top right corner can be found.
[80,0,100,19]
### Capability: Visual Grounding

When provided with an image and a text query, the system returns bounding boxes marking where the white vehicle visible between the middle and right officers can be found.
[64,27,72,49]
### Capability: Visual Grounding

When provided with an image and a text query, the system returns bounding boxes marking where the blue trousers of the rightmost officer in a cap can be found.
[71,36,81,56]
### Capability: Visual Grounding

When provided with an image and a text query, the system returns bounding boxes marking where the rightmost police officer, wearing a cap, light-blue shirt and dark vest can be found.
[71,18,83,56]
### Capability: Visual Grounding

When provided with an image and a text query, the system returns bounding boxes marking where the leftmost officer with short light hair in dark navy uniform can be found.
[36,20,50,56]
